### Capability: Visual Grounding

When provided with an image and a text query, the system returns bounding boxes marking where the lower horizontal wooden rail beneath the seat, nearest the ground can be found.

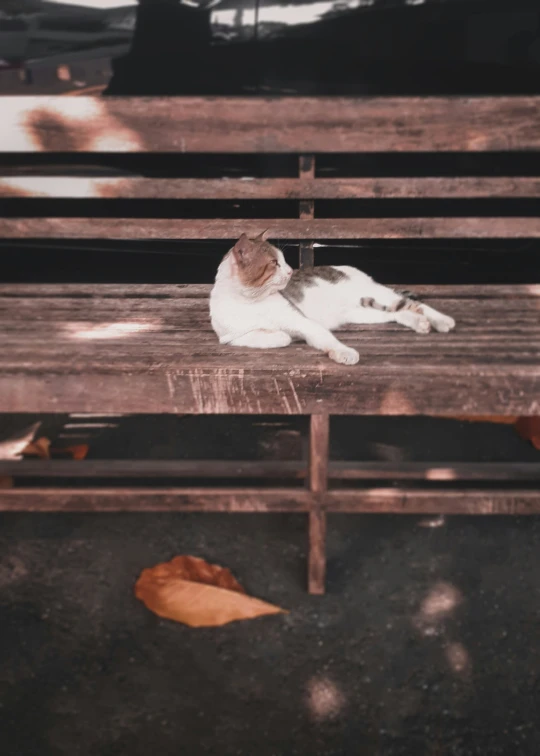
[0,487,540,515]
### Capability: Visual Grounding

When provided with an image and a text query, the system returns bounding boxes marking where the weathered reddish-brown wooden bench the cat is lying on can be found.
[0,97,540,593]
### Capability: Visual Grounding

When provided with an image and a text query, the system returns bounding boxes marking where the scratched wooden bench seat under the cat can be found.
[0,284,540,415]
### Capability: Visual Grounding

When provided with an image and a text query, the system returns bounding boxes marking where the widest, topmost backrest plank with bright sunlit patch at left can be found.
[2,96,540,153]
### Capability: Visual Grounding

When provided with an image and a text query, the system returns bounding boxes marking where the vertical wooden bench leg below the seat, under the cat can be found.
[308,415,330,595]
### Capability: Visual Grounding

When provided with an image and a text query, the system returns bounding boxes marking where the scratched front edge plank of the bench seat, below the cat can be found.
[0,364,540,417]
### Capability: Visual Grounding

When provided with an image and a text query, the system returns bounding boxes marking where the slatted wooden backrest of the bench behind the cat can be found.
[0,97,540,264]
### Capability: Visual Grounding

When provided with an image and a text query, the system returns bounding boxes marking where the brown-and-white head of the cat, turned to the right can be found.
[229,231,292,298]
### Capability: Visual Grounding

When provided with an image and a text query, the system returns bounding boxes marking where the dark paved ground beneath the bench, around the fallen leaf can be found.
[0,419,540,756]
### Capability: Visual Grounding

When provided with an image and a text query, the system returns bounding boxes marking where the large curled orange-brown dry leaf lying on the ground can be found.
[135,556,285,627]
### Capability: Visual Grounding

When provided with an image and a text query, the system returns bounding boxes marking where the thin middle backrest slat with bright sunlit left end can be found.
[0,176,540,199]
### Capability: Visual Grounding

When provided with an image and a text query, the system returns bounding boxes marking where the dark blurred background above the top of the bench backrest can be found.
[0,0,540,95]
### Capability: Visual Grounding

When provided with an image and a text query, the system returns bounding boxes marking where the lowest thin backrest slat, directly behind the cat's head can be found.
[4,217,540,240]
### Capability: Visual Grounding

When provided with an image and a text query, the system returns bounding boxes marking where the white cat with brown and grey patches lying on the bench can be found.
[210,231,455,365]
